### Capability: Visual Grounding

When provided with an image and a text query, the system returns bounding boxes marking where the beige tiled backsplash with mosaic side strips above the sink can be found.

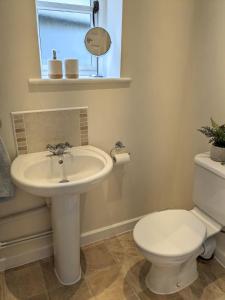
[12,107,88,154]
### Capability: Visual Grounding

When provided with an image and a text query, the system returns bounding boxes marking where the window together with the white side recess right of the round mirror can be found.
[36,0,123,78]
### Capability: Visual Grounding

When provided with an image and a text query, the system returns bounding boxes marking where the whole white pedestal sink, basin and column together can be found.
[11,146,113,285]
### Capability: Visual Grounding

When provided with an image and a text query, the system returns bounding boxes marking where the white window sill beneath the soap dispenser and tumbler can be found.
[29,77,132,87]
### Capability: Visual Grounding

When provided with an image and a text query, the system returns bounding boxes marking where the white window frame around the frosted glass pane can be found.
[36,0,98,78]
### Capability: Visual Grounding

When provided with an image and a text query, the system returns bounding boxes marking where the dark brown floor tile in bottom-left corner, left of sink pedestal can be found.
[5,263,46,300]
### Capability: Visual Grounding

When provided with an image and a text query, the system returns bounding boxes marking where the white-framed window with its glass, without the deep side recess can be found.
[36,0,96,77]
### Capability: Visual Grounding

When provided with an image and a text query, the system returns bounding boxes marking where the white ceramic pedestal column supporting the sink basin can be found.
[51,195,81,285]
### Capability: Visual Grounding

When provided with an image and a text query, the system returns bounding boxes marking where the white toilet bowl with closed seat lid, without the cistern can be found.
[133,208,221,294]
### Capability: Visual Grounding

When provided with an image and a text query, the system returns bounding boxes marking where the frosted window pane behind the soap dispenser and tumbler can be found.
[38,9,96,75]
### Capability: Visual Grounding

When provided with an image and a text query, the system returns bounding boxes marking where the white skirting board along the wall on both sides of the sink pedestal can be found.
[0,213,142,272]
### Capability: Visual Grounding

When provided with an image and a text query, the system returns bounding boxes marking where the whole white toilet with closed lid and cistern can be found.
[133,153,225,294]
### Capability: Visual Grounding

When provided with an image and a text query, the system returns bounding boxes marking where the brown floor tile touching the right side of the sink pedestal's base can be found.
[81,242,116,275]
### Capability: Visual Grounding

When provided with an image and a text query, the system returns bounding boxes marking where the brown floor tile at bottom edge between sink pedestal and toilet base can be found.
[86,265,138,300]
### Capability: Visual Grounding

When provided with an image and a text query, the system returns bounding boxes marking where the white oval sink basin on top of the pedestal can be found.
[11,146,112,197]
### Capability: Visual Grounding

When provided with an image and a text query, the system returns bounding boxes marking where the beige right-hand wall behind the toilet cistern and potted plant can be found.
[191,0,225,251]
